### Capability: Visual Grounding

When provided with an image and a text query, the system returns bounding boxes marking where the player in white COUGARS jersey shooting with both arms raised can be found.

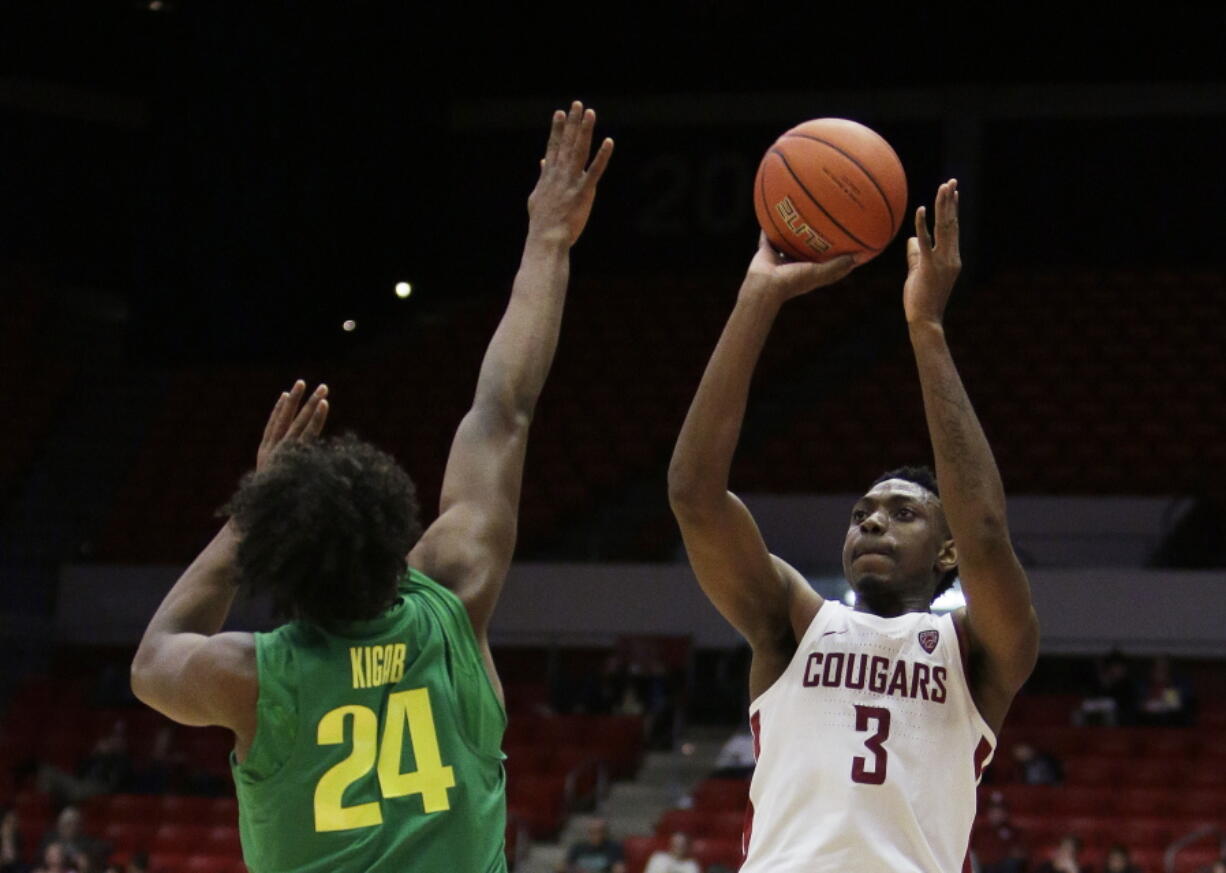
[668,180,1038,873]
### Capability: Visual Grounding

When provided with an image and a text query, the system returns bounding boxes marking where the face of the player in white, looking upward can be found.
[843,479,949,592]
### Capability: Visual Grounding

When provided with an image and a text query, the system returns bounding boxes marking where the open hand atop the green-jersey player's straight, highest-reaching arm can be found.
[528,101,613,245]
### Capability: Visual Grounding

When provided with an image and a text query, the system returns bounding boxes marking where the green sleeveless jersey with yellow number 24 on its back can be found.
[232,570,506,873]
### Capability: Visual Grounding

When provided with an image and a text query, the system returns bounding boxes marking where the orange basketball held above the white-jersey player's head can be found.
[754,118,907,261]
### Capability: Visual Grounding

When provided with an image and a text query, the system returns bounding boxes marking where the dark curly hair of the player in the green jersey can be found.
[222,434,422,628]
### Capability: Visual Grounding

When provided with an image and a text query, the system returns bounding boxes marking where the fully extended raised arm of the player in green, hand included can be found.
[408,102,613,640]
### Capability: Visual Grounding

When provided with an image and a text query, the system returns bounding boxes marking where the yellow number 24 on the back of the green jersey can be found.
[315,688,456,831]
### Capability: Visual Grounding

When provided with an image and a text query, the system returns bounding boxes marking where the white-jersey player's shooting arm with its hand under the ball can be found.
[668,237,855,687]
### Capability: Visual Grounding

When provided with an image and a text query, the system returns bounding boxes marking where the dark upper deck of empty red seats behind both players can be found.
[0,271,1226,562]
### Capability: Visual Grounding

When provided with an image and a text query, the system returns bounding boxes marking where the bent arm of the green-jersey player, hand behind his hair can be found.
[131,381,327,738]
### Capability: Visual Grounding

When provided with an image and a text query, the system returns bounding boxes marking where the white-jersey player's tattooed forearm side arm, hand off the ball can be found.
[902,179,1038,725]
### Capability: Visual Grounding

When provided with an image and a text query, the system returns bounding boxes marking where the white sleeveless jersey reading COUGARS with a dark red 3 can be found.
[741,601,996,873]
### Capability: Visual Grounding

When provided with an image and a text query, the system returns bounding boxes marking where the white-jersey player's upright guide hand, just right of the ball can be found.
[902,179,962,324]
